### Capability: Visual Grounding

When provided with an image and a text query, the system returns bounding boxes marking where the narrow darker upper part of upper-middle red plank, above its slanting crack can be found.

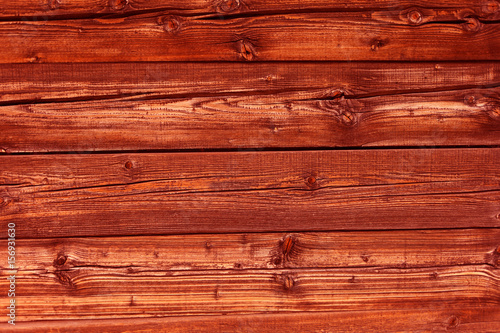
[0,61,500,105]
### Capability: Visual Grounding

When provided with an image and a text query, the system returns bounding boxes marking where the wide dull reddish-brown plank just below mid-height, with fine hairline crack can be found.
[0,148,500,238]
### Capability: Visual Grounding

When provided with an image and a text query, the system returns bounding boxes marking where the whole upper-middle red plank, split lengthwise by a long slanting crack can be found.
[0,63,500,152]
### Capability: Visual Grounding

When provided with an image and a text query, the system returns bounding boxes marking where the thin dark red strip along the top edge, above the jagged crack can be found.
[0,0,499,20]
